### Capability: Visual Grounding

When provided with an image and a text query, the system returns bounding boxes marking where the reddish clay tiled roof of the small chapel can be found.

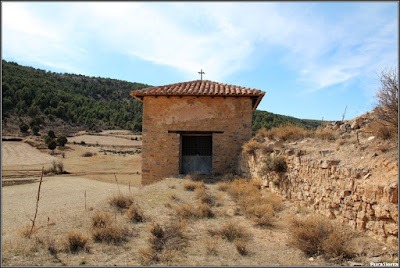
[131,80,265,109]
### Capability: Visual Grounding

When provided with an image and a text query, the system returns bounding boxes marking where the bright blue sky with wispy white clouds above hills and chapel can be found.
[1,1,399,120]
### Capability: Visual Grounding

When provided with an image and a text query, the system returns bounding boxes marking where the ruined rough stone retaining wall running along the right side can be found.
[240,149,398,246]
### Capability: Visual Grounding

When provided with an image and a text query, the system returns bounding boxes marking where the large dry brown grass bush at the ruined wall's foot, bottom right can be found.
[289,215,353,258]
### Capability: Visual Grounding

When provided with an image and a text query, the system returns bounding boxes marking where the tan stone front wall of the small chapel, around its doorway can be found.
[142,96,252,184]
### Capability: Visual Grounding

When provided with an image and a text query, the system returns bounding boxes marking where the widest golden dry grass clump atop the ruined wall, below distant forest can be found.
[264,124,312,141]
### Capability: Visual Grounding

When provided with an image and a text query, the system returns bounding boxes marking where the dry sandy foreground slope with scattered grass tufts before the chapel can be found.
[2,176,390,266]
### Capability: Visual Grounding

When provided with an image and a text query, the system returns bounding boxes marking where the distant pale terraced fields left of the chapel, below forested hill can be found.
[2,130,141,185]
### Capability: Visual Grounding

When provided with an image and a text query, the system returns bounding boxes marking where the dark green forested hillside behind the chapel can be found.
[2,60,320,132]
